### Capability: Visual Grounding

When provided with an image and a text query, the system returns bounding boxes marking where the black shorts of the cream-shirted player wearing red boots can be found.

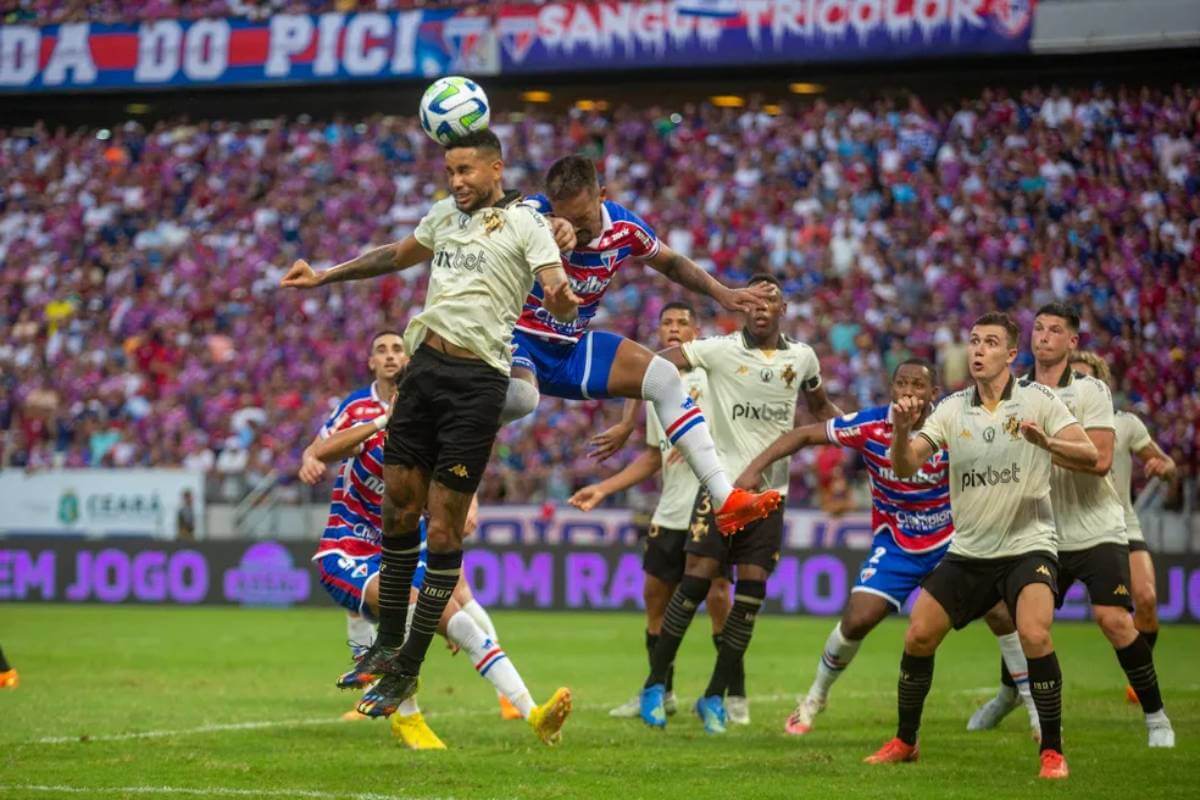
[920,551,1058,630]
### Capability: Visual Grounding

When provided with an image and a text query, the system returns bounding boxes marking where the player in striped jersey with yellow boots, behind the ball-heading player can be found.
[300,332,570,750]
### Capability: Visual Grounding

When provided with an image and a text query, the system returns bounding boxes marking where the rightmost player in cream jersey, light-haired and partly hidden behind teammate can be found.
[1070,350,1176,703]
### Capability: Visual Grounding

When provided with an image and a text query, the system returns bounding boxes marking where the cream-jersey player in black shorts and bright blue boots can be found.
[640,275,841,733]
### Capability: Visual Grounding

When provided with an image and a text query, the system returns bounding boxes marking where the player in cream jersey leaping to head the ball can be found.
[282,131,578,716]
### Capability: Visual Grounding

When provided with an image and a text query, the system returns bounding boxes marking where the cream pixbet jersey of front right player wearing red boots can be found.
[918,378,1075,559]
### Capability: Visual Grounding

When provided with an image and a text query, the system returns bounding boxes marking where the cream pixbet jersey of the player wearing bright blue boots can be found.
[683,332,821,495]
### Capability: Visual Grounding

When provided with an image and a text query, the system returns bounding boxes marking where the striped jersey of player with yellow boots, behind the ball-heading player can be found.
[313,384,388,560]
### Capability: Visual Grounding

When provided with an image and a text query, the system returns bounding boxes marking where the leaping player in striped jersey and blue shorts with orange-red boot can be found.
[511,156,781,535]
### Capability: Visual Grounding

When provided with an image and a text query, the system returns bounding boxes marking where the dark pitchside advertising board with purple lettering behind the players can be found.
[0,537,1200,624]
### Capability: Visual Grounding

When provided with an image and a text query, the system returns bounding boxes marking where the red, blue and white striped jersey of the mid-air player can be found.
[516,194,659,342]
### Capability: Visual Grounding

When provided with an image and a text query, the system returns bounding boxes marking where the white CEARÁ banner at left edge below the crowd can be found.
[0,469,204,539]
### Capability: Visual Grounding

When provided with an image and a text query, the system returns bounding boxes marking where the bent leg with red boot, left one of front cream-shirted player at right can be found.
[864,591,952,764]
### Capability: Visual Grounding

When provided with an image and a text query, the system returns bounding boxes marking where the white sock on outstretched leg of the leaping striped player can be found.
[642,355,733,511]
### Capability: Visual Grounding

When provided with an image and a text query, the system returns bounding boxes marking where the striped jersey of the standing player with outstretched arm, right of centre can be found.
[826,405,954,553]
